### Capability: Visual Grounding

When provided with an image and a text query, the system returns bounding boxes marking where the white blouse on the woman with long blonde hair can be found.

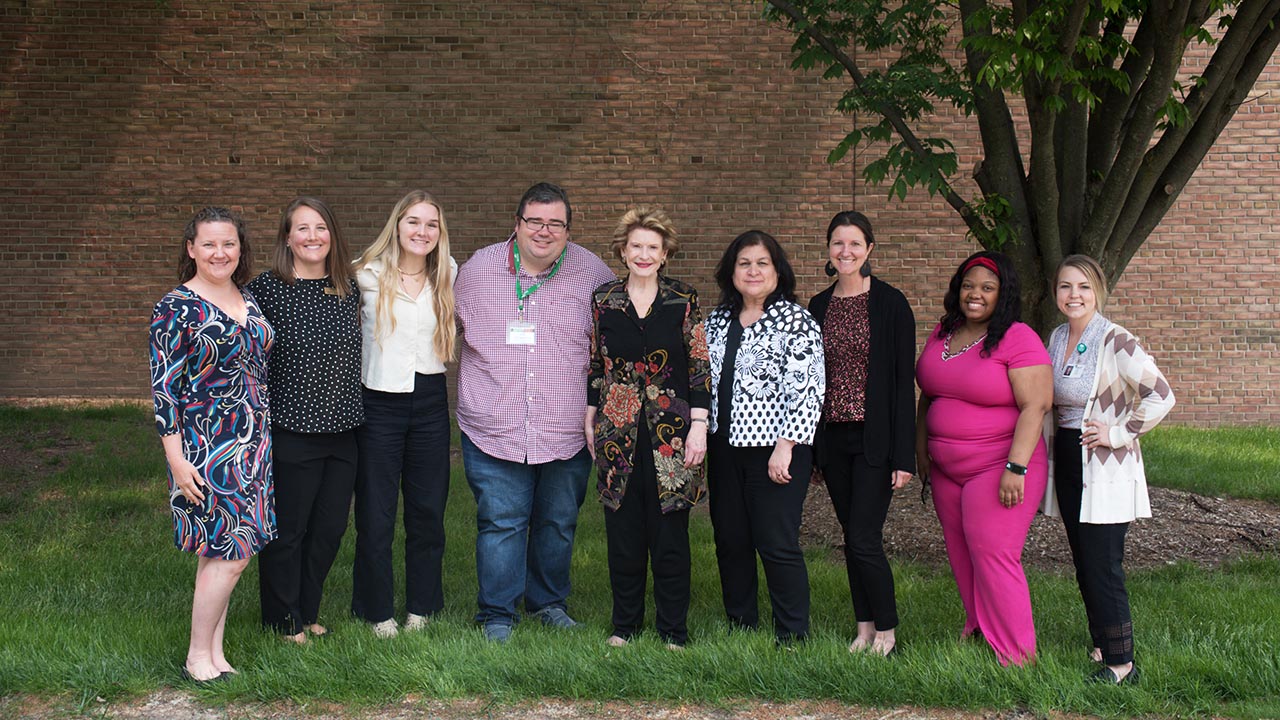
[356,258,458,392]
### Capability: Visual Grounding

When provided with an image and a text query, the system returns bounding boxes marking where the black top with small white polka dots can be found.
[248,270,365,433]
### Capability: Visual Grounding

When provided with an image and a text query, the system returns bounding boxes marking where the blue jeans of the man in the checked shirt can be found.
[462,433,591,624]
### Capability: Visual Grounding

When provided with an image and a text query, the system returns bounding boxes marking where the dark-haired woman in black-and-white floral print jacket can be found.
[707,231,826,644]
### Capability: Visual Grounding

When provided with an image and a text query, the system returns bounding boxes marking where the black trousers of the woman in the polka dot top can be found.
[257,428,356,635]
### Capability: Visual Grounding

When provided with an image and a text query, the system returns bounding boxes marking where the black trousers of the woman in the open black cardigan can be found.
[822,423,897,630]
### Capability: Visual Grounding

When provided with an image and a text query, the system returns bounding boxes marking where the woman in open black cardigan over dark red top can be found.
[809,211,915,655]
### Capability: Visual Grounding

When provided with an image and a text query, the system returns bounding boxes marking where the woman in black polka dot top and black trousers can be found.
[248,197,365,643]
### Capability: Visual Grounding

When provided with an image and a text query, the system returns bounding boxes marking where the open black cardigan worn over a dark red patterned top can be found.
[809,275,915,474]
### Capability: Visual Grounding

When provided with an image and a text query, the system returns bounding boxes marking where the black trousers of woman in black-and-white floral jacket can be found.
[707,434,813,642]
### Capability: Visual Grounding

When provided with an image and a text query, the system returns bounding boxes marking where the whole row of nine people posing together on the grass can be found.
[151,183,1174,683]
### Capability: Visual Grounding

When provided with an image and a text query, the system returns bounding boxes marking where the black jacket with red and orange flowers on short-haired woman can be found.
[586,277,710,512]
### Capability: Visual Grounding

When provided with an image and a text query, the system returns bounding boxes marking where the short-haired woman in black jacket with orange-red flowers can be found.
[585,206,710,650]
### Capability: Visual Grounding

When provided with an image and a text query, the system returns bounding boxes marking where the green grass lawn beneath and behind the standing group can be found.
[0,407,1280,717]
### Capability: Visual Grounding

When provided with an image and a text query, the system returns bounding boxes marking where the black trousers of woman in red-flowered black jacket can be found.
[604,425,690,644]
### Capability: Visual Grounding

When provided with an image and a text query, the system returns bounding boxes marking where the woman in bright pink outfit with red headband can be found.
[915,252,1053,665]
